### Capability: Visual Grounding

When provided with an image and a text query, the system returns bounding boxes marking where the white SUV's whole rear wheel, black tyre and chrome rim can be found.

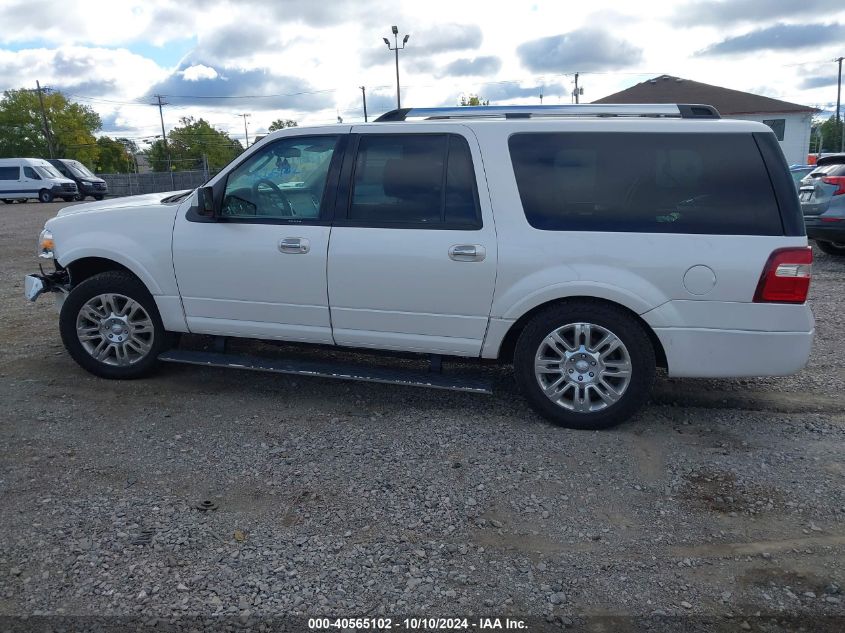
[514,301,656,430]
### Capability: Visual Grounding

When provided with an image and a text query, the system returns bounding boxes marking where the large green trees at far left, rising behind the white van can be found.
[0,90,102,165]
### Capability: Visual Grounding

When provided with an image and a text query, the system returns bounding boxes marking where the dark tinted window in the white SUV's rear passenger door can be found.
[348,134,480,228]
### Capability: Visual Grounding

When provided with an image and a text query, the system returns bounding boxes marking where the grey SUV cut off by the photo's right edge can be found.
[798,155,845,256]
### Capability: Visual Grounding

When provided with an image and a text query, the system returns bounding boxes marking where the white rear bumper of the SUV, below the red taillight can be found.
[654,328,815,378]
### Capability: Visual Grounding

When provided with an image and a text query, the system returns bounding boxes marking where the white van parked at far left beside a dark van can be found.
[0,158,78,204]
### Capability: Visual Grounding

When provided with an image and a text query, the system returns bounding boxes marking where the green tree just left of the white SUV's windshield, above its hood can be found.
[145,117,244,171]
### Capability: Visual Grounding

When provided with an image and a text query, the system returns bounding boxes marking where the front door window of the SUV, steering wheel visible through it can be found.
[221,136,340,221]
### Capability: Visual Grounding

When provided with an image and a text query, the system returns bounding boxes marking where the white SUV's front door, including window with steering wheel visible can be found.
[173,126,349,343]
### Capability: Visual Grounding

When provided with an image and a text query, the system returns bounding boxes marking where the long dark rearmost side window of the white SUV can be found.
[509,132,783,235]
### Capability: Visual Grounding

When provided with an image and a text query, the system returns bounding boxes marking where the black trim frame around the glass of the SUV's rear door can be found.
[333,132,484,231]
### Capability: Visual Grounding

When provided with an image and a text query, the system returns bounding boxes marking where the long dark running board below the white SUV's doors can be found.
[158,349,493,394]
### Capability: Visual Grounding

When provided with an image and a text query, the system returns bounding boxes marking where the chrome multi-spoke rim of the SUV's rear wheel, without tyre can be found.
[534,323,631,413]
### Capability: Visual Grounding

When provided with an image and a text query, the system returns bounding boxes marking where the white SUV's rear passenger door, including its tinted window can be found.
[328,124,497,356]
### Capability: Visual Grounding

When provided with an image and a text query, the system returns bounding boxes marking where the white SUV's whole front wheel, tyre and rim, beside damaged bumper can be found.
[59,271,170,378]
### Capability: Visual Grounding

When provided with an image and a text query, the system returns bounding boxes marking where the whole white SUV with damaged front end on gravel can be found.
[26,105,814,428]
